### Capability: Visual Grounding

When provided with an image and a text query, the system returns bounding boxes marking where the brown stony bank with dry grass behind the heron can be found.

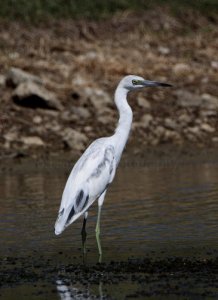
[0,8,218,155]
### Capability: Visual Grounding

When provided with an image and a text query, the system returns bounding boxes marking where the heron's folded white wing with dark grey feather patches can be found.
[55,138,116,232]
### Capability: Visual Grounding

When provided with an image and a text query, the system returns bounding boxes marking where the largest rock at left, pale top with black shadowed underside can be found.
[12,81,62,110]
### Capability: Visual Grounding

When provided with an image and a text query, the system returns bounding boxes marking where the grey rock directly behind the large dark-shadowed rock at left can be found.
[6,68,42,87]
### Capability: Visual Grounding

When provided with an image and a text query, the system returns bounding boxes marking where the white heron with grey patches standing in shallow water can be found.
[55,75,171,256]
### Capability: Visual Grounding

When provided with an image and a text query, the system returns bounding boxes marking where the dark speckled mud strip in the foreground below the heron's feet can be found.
[0,253,218,299]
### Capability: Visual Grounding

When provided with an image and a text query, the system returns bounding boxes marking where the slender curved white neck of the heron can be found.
[114,86,132,155]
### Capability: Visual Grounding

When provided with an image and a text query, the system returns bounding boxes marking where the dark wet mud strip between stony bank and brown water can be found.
[0,145,218,173]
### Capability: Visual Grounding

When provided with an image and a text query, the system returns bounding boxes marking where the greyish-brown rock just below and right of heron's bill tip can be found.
[175,90,202,107]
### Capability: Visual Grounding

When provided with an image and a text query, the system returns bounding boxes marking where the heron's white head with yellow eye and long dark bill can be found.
[120,75,172,91]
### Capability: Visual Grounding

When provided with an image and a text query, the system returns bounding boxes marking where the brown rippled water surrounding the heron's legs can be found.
[0,156,218,299]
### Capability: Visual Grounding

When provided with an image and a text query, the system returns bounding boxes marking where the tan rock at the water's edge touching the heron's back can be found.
[61,127,88,151]
